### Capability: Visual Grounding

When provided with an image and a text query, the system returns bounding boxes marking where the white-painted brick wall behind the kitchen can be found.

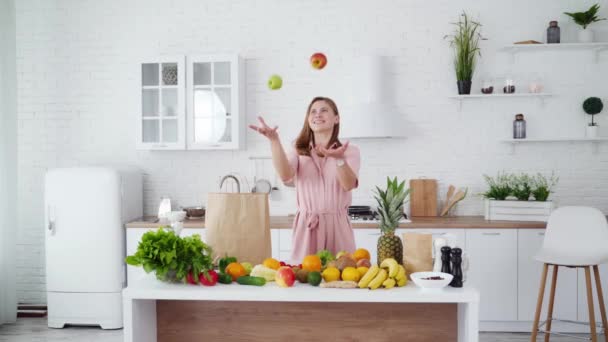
[17,0,608,302]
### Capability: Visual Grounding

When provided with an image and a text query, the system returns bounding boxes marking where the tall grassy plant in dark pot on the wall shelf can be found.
[446,12,482,95]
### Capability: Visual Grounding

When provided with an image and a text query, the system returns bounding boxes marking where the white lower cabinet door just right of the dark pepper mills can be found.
[465,229,517,321]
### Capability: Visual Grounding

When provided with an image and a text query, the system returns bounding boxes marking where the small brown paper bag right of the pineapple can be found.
[403,233,433,276]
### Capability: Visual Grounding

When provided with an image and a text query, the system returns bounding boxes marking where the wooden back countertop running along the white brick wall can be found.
[126,215,547,229]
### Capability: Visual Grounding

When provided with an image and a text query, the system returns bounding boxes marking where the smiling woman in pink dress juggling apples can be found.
[249,97,360,262]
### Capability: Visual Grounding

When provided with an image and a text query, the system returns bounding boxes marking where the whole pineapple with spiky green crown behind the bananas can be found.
[374,177,410,265]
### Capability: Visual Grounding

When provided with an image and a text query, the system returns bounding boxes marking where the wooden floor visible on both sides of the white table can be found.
[0,318,592,342]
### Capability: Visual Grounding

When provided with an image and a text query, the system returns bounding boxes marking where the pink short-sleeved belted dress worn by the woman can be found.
[288,144,361,262]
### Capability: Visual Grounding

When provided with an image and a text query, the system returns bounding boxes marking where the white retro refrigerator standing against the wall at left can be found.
[44,167,143,329]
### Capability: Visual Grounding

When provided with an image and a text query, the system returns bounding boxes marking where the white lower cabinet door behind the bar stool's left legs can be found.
[517,229,577,321]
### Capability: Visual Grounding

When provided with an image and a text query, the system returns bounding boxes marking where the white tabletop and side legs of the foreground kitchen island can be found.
[123,275,479,342]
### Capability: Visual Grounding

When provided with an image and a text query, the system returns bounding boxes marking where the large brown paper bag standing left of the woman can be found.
[205,193,272,265]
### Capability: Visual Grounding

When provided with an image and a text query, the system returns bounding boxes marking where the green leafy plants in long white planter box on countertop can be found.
[483,173,557,221]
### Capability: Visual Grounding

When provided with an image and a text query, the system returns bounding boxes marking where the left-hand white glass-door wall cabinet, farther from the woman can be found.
[136,56,186,150]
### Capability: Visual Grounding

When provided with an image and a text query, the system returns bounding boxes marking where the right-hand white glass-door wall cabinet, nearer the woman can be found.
[186,54,245,150]
